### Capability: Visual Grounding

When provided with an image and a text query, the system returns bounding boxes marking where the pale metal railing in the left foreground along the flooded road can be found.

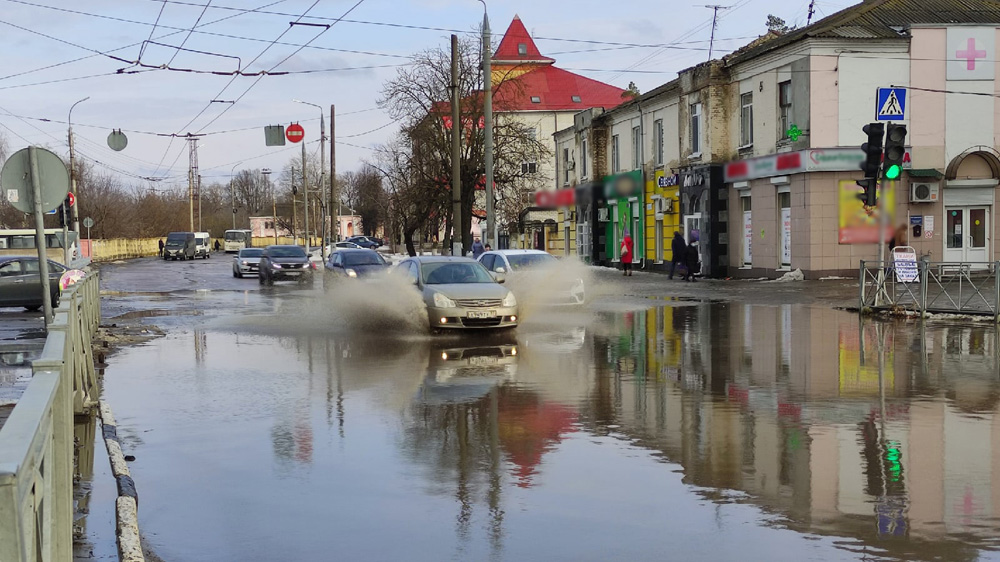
[0,272,100,562]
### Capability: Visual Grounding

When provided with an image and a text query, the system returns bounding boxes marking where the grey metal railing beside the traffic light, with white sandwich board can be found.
[858,260,1000,322]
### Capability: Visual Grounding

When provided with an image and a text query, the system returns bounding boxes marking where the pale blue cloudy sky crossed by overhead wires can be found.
[0,0,857,189]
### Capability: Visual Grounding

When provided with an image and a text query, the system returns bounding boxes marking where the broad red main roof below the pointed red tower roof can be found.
[493,66,625,111]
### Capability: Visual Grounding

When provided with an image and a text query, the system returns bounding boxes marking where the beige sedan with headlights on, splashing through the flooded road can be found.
[395,256,518,332]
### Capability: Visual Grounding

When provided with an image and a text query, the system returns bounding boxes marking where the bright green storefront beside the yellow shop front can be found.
[604,170,646,265]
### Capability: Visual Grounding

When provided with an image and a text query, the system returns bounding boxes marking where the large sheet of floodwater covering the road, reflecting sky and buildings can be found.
[99,302,1000,561]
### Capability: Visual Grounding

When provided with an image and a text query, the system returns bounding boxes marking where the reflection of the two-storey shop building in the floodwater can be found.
[583,304,1000,559]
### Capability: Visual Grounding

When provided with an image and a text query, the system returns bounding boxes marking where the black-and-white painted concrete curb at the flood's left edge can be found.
[100,400,146,562]
